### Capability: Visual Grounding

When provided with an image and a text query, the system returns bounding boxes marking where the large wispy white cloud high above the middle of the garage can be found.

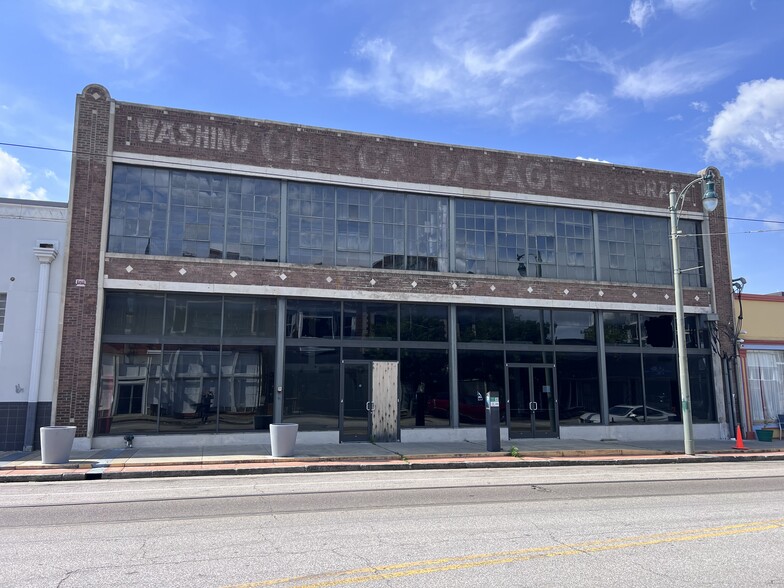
[333,15,572,120]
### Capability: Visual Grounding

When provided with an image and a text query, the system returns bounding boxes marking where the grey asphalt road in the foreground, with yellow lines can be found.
[0,462,784,588]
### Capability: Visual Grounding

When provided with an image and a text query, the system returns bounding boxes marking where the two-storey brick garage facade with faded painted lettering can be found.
[53,85,732,446]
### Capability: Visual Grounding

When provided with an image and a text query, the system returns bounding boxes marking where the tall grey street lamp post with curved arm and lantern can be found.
[669,167,719,455]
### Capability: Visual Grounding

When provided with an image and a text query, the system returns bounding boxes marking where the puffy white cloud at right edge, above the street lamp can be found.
[705,78,784,167]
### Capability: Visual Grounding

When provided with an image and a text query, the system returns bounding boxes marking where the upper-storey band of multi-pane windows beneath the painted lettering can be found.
[108,165,705,287]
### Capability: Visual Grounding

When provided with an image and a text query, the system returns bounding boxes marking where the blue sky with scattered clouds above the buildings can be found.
[0,0,784,293]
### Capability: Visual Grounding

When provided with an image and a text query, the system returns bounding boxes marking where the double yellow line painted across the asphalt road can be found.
[227,518,784,588]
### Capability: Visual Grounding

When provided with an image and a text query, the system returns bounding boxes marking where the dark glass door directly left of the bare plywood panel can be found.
[340,362,372,443]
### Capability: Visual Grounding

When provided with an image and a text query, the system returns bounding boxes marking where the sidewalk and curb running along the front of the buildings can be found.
[0,439,784,482]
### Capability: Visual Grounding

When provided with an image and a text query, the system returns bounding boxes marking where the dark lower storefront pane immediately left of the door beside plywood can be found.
[283,346,340,431]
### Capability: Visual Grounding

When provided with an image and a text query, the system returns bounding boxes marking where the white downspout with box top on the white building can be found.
[24,241,57,451]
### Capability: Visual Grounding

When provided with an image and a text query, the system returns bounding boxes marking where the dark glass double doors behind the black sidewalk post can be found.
[507,365,558,439]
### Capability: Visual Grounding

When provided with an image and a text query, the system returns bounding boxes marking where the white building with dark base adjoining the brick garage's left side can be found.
[0,198,68,451]
